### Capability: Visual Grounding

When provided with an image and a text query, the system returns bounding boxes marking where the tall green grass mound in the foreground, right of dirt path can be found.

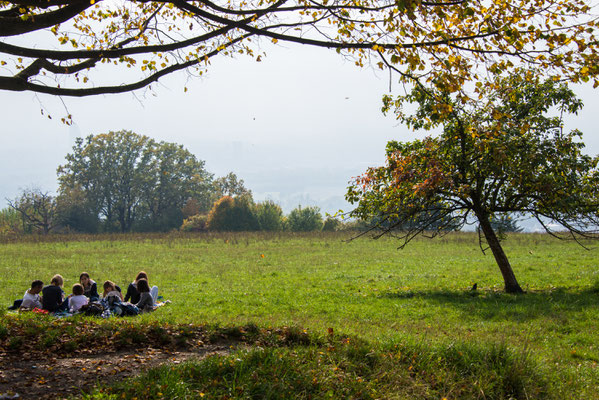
[84,340,558,399]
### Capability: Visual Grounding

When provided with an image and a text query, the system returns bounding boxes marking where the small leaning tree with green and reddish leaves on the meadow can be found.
[346,71,599,293]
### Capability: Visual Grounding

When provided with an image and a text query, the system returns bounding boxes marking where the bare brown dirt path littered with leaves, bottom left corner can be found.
[0,345,230,399]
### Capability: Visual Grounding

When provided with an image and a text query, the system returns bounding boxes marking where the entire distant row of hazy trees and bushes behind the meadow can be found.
[0,131,356,234]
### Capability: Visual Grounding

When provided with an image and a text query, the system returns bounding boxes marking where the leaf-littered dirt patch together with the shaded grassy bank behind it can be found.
[0,314,314,399]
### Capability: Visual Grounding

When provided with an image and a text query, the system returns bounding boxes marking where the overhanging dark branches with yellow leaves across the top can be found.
[0,0,599,96]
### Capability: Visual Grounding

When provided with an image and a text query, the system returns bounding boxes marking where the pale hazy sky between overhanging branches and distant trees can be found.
[0,45,599,216]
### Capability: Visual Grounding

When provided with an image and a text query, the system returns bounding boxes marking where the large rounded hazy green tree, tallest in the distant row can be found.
[58,131,212,232]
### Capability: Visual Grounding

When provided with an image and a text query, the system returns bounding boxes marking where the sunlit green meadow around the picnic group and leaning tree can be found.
[0,233,599,398]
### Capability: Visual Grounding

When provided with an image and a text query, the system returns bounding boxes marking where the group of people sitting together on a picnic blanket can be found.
[9,271,158,316]
